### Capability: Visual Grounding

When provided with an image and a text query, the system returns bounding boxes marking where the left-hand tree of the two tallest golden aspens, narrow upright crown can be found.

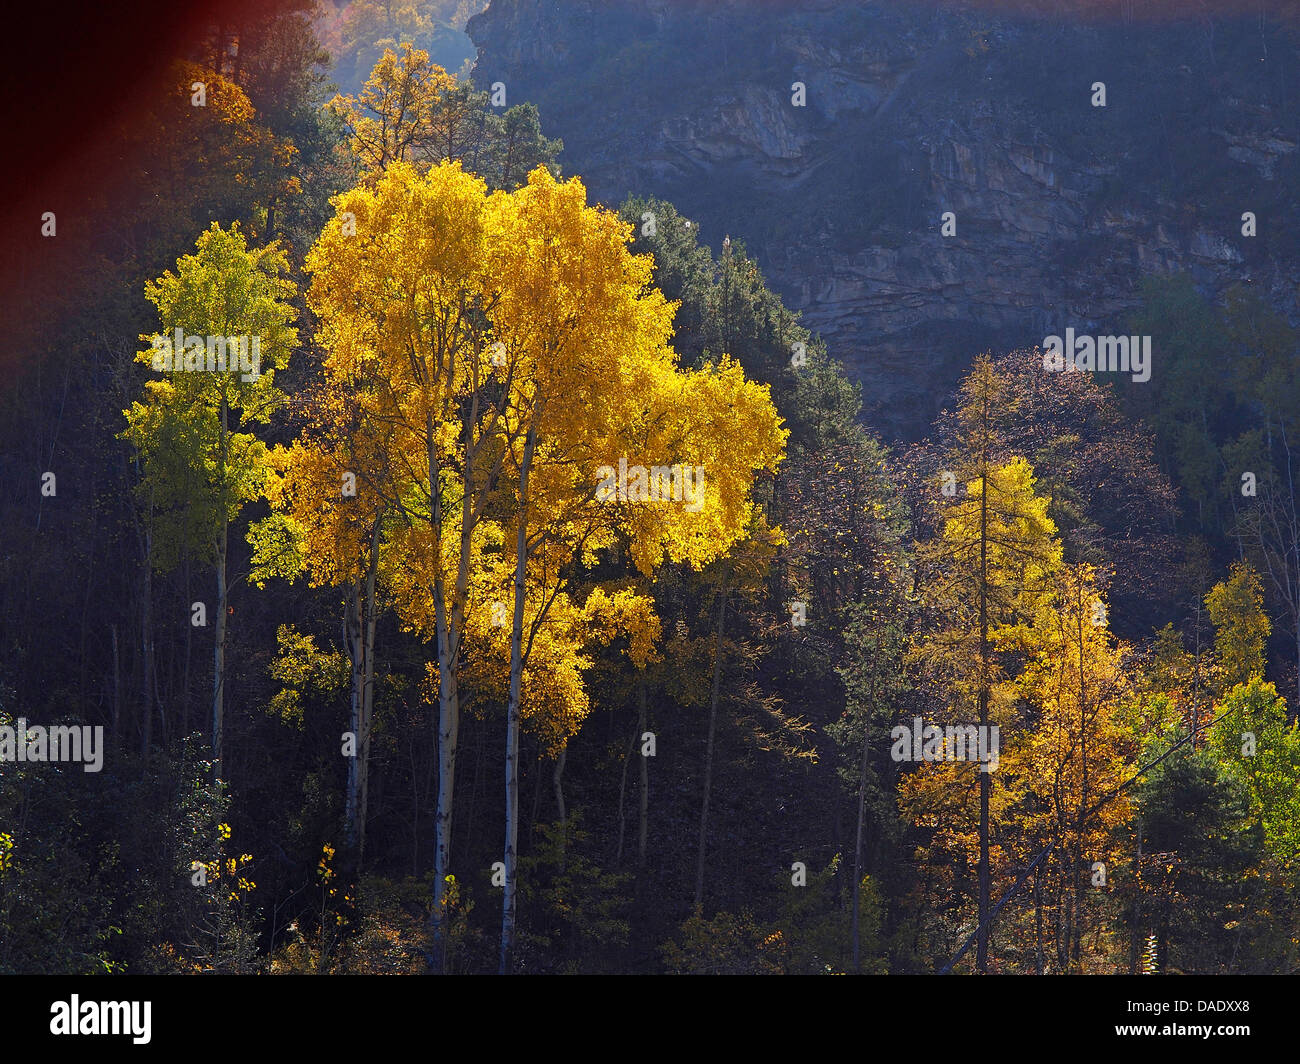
[307,161,510,970]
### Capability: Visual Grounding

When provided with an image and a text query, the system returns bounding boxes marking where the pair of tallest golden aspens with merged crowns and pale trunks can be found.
[308,161,784,969]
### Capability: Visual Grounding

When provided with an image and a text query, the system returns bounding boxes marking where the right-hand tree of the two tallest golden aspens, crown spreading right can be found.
[489,166,785,972]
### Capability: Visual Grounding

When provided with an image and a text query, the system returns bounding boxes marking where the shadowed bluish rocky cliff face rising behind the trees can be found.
[468,0,1300,437]
